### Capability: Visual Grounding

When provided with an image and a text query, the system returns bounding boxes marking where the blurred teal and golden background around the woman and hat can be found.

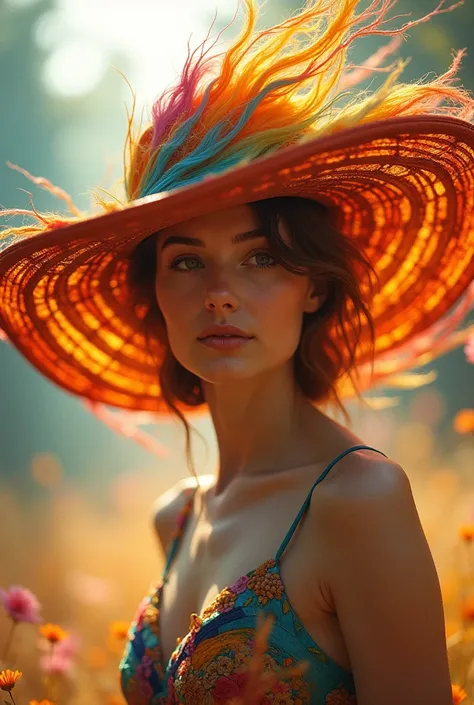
[0,0,474,703]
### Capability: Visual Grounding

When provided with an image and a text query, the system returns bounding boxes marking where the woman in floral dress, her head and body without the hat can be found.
[126,198,456,705]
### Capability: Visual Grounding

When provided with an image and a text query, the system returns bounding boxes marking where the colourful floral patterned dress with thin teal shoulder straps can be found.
[120,445,384,705]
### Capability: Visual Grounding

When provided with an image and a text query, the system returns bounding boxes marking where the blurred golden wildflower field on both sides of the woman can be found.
[0,335,474,705]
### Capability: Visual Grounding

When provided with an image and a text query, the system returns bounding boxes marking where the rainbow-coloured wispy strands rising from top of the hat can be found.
[125,0,474,200]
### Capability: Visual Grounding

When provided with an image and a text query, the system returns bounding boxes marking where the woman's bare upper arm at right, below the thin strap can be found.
[311,456,452,705]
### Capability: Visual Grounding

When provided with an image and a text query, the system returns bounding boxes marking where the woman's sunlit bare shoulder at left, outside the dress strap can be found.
[151,475,214,554]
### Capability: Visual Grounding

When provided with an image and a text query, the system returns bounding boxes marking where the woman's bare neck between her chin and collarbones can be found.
[203,365,328,496]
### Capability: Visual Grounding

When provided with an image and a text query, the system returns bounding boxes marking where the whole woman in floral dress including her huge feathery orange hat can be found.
[0,0,474,705]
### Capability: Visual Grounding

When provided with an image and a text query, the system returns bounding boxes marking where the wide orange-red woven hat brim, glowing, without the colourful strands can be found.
[0,0,474,411]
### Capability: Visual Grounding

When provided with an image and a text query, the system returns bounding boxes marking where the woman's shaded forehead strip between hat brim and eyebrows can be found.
[161,204,260,239]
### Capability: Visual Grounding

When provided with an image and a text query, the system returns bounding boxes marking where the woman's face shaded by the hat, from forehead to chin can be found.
[155,205,320,383]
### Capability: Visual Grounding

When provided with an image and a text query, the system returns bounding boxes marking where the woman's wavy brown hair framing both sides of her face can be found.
[127,196,378,476]
